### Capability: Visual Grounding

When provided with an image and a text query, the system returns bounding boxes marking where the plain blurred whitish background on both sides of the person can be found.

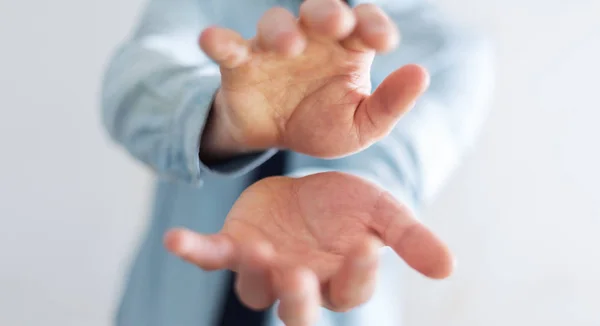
[0,0,600,326]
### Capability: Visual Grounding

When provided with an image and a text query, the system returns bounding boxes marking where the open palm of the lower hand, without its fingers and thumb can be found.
[223,173,380,281]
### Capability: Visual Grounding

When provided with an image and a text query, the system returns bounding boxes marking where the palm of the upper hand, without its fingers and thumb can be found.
[221,38,374,157]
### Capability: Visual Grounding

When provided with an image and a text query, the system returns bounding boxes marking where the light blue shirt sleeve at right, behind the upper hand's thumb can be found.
[290,1,493,209]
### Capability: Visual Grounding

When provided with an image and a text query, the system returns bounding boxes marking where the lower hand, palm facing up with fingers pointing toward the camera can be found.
[165,172,453,326]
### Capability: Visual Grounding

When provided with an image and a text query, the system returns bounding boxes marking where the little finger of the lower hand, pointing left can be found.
[164,229,237,271]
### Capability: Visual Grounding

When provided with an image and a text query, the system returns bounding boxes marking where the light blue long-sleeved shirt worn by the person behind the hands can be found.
[102,0,492,326]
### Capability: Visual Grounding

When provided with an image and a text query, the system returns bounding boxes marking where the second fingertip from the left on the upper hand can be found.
[257,7,306,56]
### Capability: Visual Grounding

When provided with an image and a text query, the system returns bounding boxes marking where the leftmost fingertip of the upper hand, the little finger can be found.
[199,27,250,69]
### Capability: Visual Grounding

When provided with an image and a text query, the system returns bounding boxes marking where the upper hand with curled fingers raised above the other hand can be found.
[200,0,428,158]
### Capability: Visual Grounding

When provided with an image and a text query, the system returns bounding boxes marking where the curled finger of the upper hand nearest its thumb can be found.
[342,4,400,52]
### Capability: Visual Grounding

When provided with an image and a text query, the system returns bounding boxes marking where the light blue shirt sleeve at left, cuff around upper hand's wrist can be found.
[102,0,274,185]
